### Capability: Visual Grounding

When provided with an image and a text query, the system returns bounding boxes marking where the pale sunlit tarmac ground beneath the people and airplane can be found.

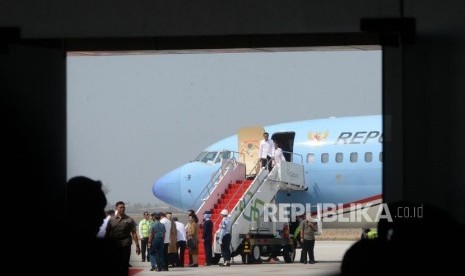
[130,241,355,276]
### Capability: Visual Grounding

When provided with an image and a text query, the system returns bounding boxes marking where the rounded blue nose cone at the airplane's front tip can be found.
[152,169,182,208]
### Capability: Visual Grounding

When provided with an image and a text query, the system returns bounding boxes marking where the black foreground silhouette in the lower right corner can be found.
[341,202,465,275]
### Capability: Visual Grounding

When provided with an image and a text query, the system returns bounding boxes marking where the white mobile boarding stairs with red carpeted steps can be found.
[190,155,306,265]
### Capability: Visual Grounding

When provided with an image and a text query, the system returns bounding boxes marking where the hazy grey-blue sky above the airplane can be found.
[67,50,382,204]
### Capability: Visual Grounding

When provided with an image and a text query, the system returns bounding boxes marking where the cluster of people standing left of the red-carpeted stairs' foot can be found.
[138,210,231,271]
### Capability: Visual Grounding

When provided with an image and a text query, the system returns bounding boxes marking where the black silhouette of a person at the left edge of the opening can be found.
[67,176,117,275]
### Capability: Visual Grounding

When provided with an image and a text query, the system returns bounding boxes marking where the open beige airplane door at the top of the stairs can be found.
[237,126,265,175]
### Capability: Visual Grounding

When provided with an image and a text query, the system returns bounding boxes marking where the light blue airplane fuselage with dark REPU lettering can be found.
[152,115,382,228]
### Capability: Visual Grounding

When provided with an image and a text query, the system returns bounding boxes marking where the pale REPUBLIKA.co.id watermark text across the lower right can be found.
[263,203,423,222]
